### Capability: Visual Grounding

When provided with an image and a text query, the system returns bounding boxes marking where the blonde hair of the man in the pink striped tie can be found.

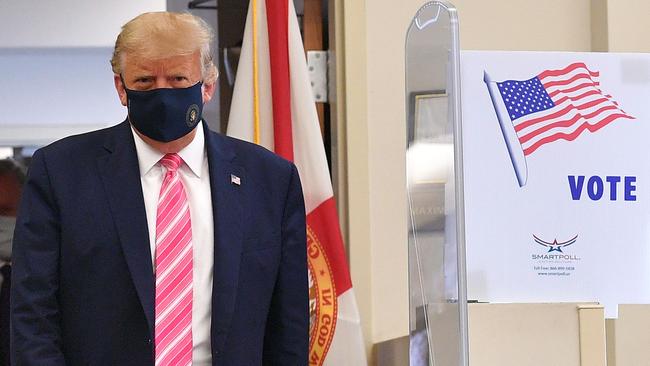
[111,12,217,84]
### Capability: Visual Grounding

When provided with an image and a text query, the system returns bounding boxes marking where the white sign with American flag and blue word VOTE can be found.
[461,51,650,317]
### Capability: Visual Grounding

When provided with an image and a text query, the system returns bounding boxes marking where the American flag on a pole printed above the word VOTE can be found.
[483,62,635,187]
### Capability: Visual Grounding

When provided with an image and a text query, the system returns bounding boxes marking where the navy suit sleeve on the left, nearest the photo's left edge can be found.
[11,150,65,366]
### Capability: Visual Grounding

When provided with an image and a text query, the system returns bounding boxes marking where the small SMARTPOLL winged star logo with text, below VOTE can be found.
[531,235,581,276]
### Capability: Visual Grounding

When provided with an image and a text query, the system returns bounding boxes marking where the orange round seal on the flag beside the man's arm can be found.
[307,225,338,365]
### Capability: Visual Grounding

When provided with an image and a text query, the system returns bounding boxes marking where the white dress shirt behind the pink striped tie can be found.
[131,122,214,366]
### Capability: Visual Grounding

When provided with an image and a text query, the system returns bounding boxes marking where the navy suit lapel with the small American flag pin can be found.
[204,123,246,350]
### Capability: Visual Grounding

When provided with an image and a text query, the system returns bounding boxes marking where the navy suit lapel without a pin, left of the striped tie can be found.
[97,121,155,336]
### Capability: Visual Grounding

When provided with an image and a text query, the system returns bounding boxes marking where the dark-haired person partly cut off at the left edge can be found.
[0,159,25,365]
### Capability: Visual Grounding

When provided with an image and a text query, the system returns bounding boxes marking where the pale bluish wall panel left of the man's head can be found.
[0,47,126,146]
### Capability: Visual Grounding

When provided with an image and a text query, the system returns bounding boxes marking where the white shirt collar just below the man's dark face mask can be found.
[131,121,205,178]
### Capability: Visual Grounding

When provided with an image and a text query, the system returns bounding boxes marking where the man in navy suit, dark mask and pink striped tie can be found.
[12,12,309,365]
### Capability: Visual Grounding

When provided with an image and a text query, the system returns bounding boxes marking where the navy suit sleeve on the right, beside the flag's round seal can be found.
[264,165,309,366]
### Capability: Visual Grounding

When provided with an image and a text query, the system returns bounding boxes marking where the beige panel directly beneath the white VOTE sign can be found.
[469,303,611,366]
